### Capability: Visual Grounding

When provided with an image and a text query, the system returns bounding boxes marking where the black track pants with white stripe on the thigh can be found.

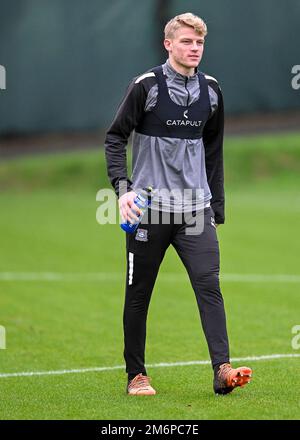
[123,208,229,375]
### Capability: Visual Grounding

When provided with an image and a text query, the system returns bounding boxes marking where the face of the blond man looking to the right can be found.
[164,26,204,68]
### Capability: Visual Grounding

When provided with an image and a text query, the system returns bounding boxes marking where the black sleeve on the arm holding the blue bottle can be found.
[105,79,147,196]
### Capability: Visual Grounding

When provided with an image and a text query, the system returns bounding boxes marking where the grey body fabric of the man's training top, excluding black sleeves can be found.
[131,61,218,212]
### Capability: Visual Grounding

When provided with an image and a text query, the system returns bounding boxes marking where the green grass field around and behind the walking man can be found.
[0,133,300,420]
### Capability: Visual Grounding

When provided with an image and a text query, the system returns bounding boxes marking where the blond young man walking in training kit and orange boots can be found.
[105,13,252,395]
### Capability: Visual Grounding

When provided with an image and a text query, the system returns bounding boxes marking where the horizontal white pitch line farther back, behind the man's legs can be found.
[0,272,300,283]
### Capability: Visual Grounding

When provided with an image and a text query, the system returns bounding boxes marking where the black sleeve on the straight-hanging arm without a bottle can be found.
[203,87,225,224]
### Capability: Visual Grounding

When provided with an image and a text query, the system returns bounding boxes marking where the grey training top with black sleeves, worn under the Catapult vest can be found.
[105,60,224,223]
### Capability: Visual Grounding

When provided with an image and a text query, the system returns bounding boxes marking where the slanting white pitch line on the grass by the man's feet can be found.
[0,353,300,378]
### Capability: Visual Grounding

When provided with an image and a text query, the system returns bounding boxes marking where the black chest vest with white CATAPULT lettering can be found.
[135,66,211,139]
